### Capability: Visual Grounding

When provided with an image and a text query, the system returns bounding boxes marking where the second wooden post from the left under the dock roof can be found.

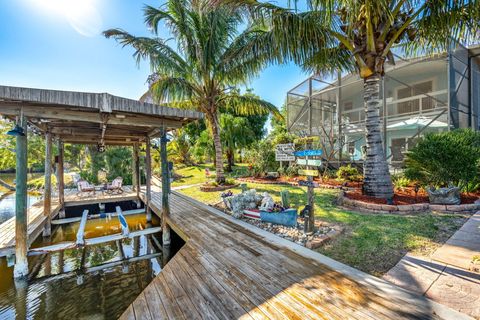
[43,131,52,237]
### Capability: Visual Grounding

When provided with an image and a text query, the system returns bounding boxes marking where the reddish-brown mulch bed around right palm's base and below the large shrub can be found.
[345,188,480,205]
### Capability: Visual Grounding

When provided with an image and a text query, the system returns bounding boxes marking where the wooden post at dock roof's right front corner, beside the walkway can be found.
[160,128,170,248]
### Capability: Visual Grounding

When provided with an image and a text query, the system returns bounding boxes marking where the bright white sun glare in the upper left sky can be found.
[31,0,102,37]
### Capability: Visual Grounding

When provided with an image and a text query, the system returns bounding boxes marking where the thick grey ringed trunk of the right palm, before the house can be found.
[363,74,393,200]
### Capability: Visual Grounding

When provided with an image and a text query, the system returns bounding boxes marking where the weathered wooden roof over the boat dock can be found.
[0,86,203,145]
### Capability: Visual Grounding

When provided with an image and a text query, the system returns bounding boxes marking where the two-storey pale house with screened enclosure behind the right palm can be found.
[287,45,480,166]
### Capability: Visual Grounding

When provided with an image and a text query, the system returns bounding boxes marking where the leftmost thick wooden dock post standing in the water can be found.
[13,115,28,278]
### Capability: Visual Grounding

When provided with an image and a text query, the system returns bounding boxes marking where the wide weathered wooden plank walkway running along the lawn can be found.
[121,192,462,320]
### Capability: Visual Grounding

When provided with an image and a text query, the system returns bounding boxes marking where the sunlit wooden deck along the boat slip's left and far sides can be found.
[0,186,138,257]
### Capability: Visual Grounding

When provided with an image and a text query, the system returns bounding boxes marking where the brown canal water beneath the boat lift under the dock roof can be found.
[0,214,163,320]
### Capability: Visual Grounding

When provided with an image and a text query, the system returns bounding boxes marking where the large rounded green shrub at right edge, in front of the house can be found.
[405,129,480,189]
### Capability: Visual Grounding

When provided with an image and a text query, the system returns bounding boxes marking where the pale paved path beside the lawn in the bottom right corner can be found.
[383,212,480,319]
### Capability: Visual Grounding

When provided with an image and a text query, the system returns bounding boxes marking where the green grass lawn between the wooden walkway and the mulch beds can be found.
[175,174,465,276]
